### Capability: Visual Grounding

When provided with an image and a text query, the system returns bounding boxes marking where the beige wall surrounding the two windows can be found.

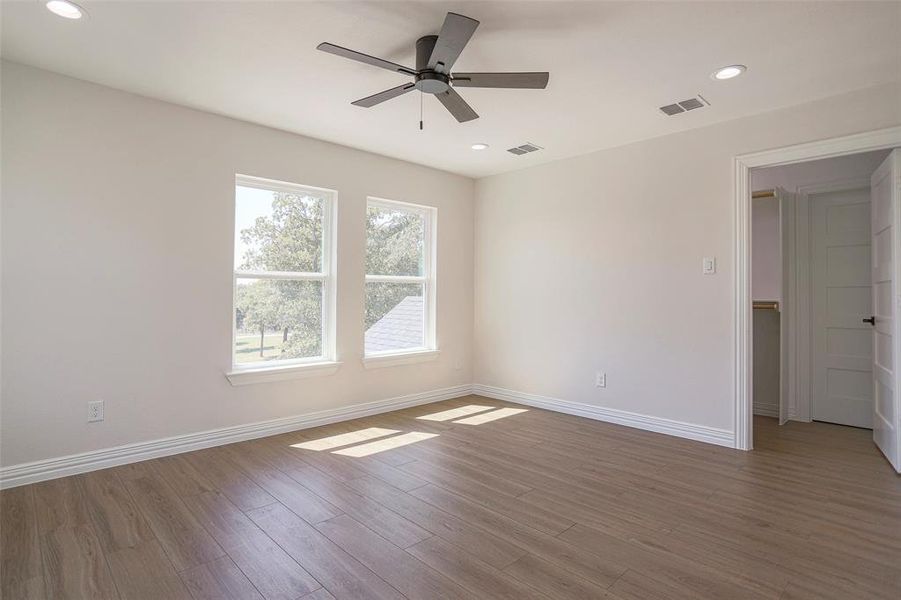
[0,63,473,465]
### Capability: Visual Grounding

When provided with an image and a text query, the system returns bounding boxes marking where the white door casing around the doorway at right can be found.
[732,127,901,450]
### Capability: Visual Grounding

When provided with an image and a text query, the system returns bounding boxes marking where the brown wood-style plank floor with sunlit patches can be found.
[0,396,901,600]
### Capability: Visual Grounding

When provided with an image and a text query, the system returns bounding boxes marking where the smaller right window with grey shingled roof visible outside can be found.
[364,198,437,359]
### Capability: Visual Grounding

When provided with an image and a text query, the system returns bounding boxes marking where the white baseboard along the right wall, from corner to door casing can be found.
[472,383,735,448]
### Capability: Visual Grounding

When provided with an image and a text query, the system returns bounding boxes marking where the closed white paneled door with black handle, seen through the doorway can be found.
[808,187,873,428]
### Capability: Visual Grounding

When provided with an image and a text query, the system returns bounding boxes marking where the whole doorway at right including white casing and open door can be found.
[735,128,901,471]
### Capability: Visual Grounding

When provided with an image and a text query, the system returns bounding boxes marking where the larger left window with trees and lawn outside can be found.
[229,175,335,376]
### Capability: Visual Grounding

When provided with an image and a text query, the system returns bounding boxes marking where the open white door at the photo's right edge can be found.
[870,149,901,472]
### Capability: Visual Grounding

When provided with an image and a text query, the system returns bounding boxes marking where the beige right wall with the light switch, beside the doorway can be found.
[475,85,901,430]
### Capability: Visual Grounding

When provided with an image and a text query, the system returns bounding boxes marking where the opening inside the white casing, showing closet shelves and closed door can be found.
[751,150,889,429]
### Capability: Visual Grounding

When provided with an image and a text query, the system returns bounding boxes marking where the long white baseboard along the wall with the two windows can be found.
[0,385,472,489]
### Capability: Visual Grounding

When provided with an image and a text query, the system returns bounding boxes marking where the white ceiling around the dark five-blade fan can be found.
[2,0,901,177]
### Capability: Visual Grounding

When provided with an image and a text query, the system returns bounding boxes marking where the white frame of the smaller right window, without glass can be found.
[363,196,438,369]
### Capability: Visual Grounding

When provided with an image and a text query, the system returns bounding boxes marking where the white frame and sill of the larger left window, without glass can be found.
[226,174,340,385]
